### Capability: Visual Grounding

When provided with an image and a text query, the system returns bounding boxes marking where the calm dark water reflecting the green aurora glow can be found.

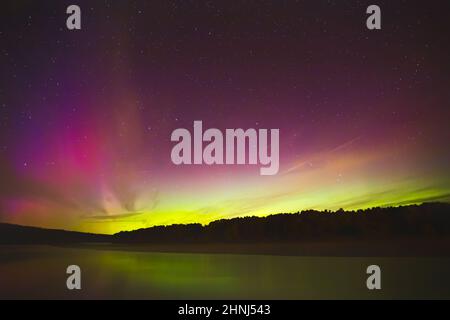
[0,246,450,299]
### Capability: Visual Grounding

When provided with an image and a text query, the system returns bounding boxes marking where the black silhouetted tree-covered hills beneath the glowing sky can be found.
[0,203,450,244]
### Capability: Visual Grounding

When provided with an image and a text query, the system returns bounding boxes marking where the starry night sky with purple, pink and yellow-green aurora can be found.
[0,0,450,233]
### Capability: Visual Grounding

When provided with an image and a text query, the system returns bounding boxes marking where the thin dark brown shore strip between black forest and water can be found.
[14,238,450,257]
